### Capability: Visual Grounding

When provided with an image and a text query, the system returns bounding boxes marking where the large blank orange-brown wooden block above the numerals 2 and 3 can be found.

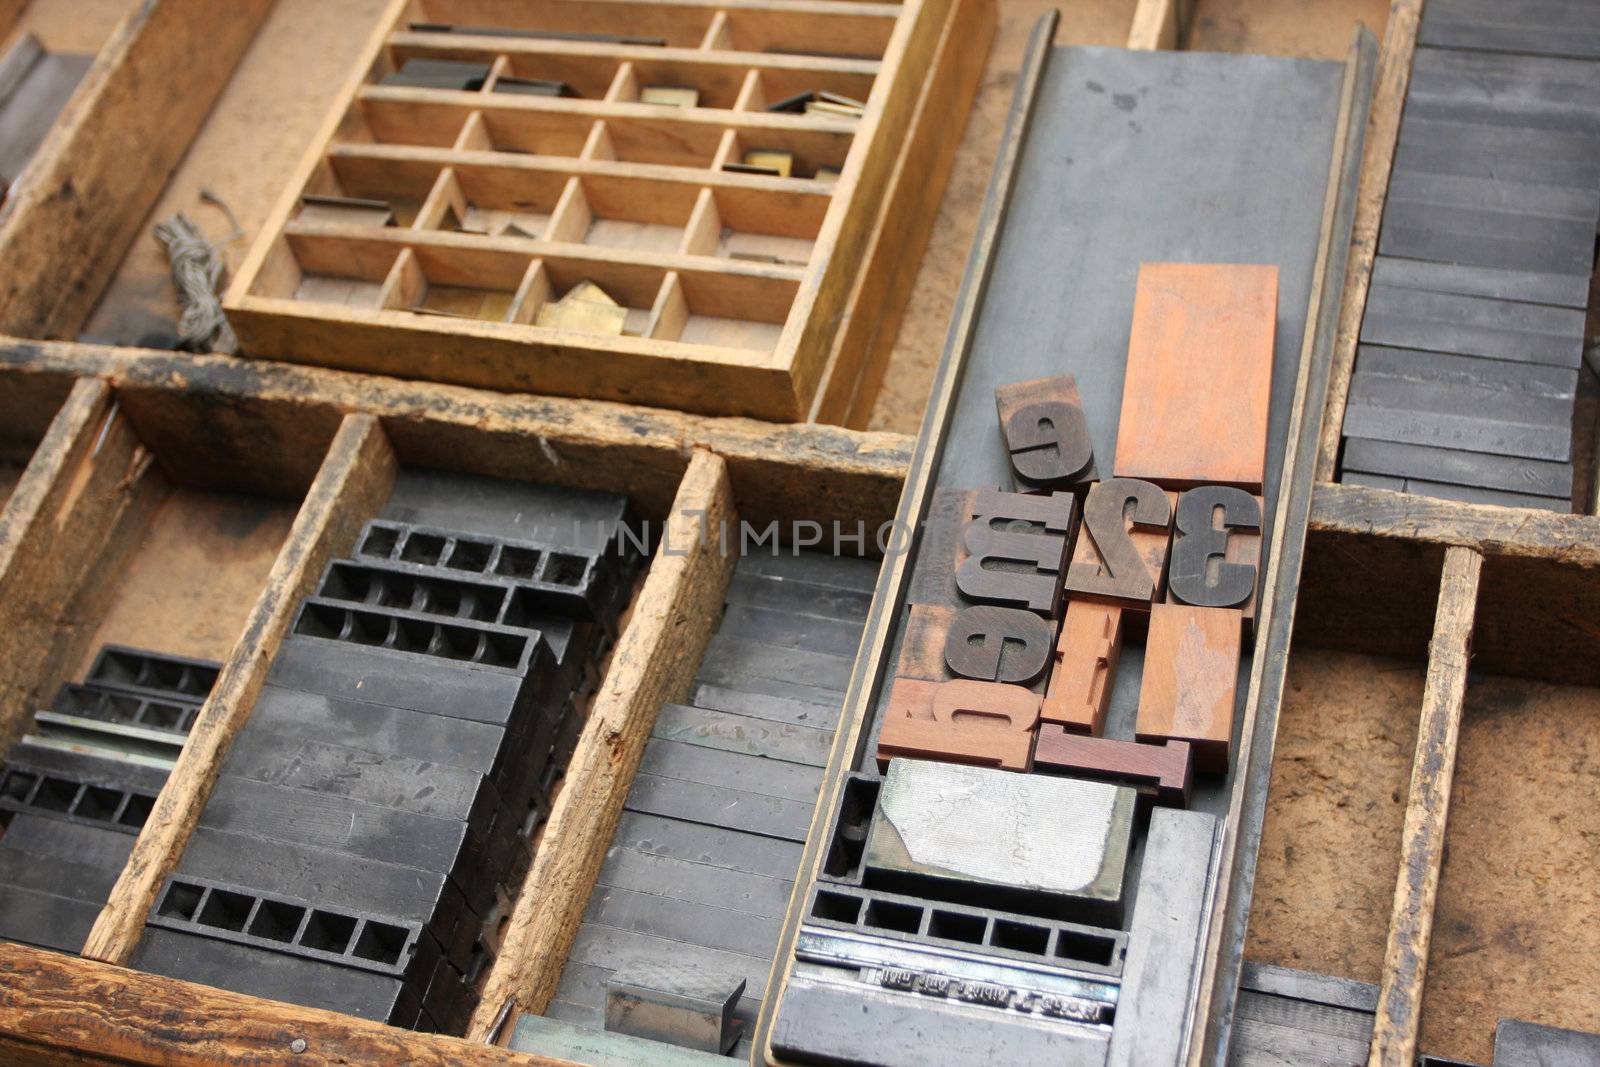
[1114,262,1278,493]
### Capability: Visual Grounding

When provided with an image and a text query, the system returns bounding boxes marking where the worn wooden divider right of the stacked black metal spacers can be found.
[467,451,739,1041]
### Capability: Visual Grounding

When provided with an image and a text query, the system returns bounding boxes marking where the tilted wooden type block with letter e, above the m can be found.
[995,374,1099,493]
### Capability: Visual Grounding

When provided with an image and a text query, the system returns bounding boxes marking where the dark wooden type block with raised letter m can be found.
[955,490,1077,619]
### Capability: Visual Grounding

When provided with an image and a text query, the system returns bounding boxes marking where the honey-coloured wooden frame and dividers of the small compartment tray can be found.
[226,0,994,422]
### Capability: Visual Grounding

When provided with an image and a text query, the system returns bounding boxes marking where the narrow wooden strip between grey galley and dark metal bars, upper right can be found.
[1315,0,1422,482]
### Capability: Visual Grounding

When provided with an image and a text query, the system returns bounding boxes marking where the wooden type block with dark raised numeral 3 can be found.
[1166,485,1262,625]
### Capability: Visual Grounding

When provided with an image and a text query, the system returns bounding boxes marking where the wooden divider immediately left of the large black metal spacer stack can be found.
[83,414,398,963]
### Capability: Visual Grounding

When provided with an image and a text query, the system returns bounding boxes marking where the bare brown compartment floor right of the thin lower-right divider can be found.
[1422,675,1600,1064]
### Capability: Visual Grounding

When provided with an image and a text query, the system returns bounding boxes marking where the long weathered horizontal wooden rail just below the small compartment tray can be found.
[0,341,912,534]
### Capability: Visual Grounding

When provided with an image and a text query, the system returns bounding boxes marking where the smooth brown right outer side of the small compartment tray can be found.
[808,0,997,429]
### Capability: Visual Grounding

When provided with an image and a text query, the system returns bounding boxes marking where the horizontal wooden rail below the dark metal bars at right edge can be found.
[1310,482,1600,569]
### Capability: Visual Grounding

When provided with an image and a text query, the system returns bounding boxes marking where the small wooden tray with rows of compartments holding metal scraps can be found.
[216,0,992,421]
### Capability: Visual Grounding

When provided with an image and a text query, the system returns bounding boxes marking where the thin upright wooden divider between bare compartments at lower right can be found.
[1366,547,1483,1067]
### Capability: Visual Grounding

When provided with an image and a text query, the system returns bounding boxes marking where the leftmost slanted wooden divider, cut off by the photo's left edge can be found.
[0,381,160,749]
